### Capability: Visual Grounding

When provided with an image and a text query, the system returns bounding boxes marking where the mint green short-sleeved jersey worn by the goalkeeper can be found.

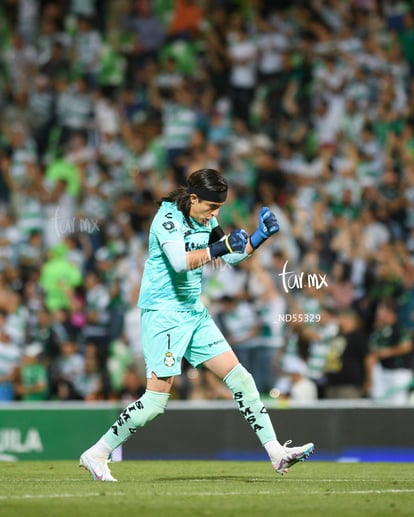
[138,201,218,311]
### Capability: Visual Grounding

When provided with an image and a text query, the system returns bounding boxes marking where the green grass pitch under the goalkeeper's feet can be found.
[0,460,414,517]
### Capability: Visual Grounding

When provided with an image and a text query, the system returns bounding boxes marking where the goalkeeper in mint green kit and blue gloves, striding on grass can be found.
[80,169,314,481]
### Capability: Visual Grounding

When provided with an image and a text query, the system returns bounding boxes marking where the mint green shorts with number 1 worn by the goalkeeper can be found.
[141,308,231,377]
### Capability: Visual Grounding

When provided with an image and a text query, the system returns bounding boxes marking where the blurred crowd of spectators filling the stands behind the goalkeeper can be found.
[0,0,414,403]
